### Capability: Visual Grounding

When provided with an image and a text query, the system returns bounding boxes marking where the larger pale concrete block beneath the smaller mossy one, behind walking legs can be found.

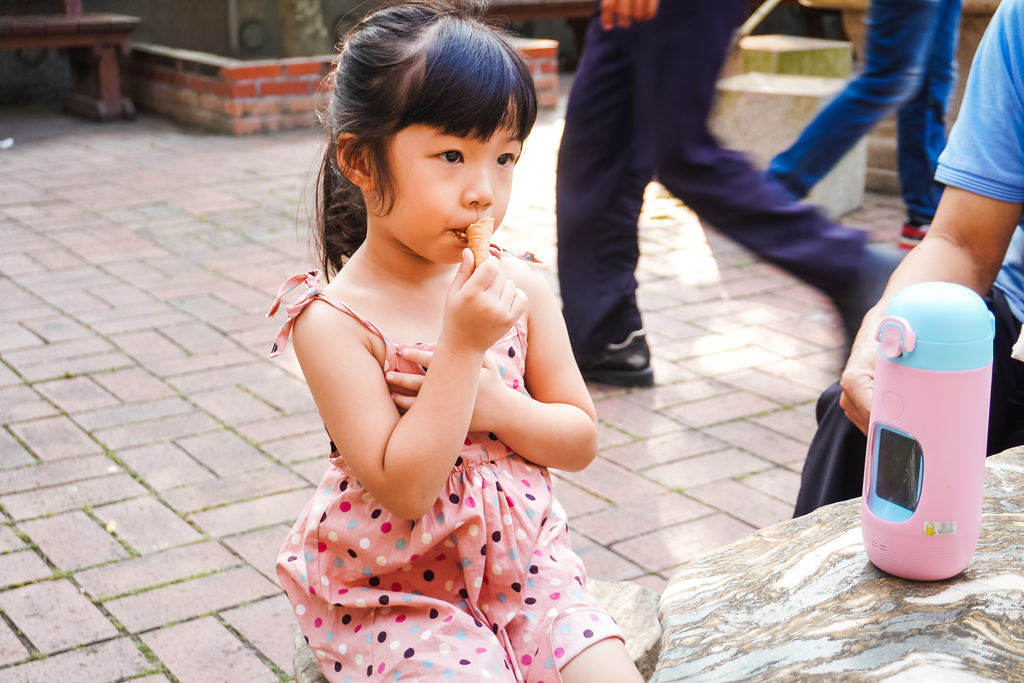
[711,73,867,219]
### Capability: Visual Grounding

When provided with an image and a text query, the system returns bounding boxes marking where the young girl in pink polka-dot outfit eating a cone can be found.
[271,2,640,683]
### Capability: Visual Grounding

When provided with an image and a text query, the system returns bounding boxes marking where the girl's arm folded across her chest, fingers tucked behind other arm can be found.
[391,253,597,471]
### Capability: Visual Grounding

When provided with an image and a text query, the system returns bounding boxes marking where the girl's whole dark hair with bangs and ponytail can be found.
[316,0,537,276]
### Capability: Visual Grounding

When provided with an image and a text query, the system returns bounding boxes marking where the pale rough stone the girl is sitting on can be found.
[292,579,662,683]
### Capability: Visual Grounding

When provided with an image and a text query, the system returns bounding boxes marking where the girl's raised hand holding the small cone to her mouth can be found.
[438,249,526,352]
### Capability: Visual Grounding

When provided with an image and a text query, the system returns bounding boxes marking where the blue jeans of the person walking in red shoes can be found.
[765,0,963,223]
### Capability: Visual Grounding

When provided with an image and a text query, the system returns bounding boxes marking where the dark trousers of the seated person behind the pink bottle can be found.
[794,290,1024,517]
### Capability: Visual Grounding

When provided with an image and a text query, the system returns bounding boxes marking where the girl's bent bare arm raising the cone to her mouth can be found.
[293,250,525,519]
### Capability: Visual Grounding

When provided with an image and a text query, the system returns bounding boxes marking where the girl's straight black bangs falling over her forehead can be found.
[399,22,537,140]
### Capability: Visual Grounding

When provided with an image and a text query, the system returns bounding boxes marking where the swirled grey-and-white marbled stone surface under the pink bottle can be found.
[651,449,1024,683]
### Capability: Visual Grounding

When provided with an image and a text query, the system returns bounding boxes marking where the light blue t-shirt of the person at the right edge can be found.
[935,0,1024,321]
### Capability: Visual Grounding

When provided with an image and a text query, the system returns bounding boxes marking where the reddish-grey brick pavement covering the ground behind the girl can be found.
[0,87,901,682]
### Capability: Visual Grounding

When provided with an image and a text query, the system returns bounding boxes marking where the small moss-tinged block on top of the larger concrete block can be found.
[739,35,853,78]
